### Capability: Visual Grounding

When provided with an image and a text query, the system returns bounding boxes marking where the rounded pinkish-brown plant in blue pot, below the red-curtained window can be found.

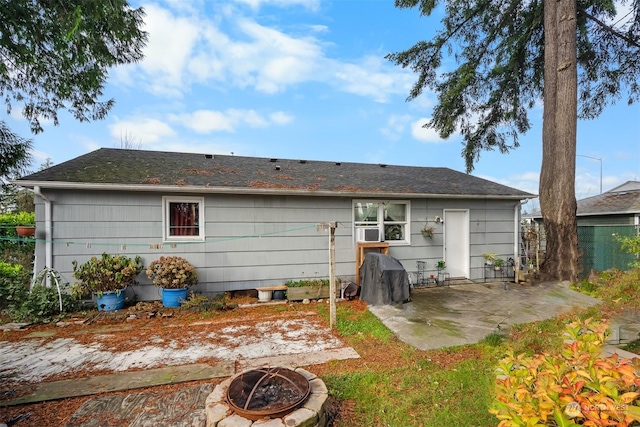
[146,256,198,307]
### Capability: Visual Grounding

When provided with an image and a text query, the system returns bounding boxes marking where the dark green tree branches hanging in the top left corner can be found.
[0,0,147,133]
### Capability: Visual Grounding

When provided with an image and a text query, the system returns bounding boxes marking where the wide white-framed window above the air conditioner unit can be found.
[353,200,411,244]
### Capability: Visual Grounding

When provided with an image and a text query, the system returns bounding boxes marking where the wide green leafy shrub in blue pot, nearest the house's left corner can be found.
[71,253,144,311]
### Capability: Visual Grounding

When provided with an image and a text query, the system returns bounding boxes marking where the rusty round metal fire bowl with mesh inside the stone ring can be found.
[227,368,310,420]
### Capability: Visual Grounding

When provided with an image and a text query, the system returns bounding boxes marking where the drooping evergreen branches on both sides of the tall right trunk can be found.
[387,0,640,172]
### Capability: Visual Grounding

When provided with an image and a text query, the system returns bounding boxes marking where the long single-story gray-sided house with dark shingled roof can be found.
[17,148,534,300]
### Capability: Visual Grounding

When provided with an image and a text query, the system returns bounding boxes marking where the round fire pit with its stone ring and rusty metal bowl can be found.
[205,367,329,427]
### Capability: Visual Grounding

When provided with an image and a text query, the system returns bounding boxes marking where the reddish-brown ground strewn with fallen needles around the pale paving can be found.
[0,300,473,427]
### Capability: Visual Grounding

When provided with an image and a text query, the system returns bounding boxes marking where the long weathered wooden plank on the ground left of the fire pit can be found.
[0,361,235,406]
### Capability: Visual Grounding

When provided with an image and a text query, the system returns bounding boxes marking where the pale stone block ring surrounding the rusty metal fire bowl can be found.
[205,367,329,427]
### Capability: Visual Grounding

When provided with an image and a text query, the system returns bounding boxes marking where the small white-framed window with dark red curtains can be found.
[162,197,204,240]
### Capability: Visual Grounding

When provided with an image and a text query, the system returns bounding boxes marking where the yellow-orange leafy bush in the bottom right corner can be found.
[489,320,640,427]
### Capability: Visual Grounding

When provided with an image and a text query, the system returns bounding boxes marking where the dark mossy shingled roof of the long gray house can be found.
[16,148,535,199]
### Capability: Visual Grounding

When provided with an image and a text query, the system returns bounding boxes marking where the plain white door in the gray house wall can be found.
[444,209,469,278]
